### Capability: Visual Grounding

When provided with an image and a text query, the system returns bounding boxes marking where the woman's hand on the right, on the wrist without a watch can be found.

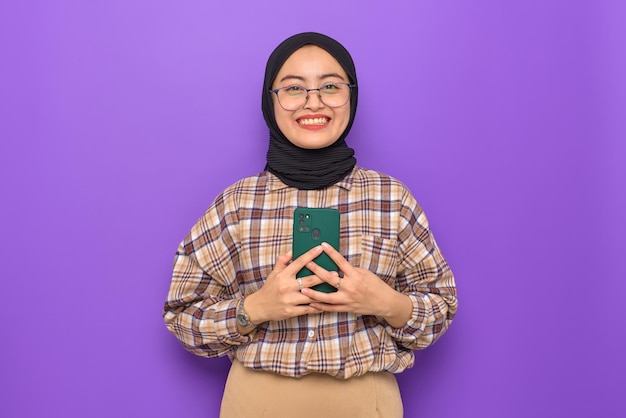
[302,243,413,328]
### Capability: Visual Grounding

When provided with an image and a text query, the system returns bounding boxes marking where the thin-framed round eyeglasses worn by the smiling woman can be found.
[270,83,356,110]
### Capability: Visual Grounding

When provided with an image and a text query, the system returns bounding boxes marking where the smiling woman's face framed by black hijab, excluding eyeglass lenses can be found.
[272,45,350,149]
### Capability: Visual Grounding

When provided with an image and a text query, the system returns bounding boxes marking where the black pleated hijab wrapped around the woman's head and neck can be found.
[261,32,358,190]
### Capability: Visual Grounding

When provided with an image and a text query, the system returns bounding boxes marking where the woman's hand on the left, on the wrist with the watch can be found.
[244,245,323,324]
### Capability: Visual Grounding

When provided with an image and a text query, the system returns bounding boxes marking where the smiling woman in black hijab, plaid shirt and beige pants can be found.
[164,33,457,418]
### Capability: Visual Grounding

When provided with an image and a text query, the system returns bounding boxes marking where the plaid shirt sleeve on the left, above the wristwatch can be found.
[163,194,254,357]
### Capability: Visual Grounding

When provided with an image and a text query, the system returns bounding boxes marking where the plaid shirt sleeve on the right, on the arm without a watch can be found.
[386,189,458,350]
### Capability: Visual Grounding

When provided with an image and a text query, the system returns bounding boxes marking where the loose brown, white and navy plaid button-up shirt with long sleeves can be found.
[163,167,457,378]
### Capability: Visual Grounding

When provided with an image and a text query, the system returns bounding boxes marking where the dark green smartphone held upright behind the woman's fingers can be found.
[292,208,339,293]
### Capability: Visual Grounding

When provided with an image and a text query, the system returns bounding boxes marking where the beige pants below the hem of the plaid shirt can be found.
[220,360,403,418]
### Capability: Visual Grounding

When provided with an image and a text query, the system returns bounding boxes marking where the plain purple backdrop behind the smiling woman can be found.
[0,0,626,418]
